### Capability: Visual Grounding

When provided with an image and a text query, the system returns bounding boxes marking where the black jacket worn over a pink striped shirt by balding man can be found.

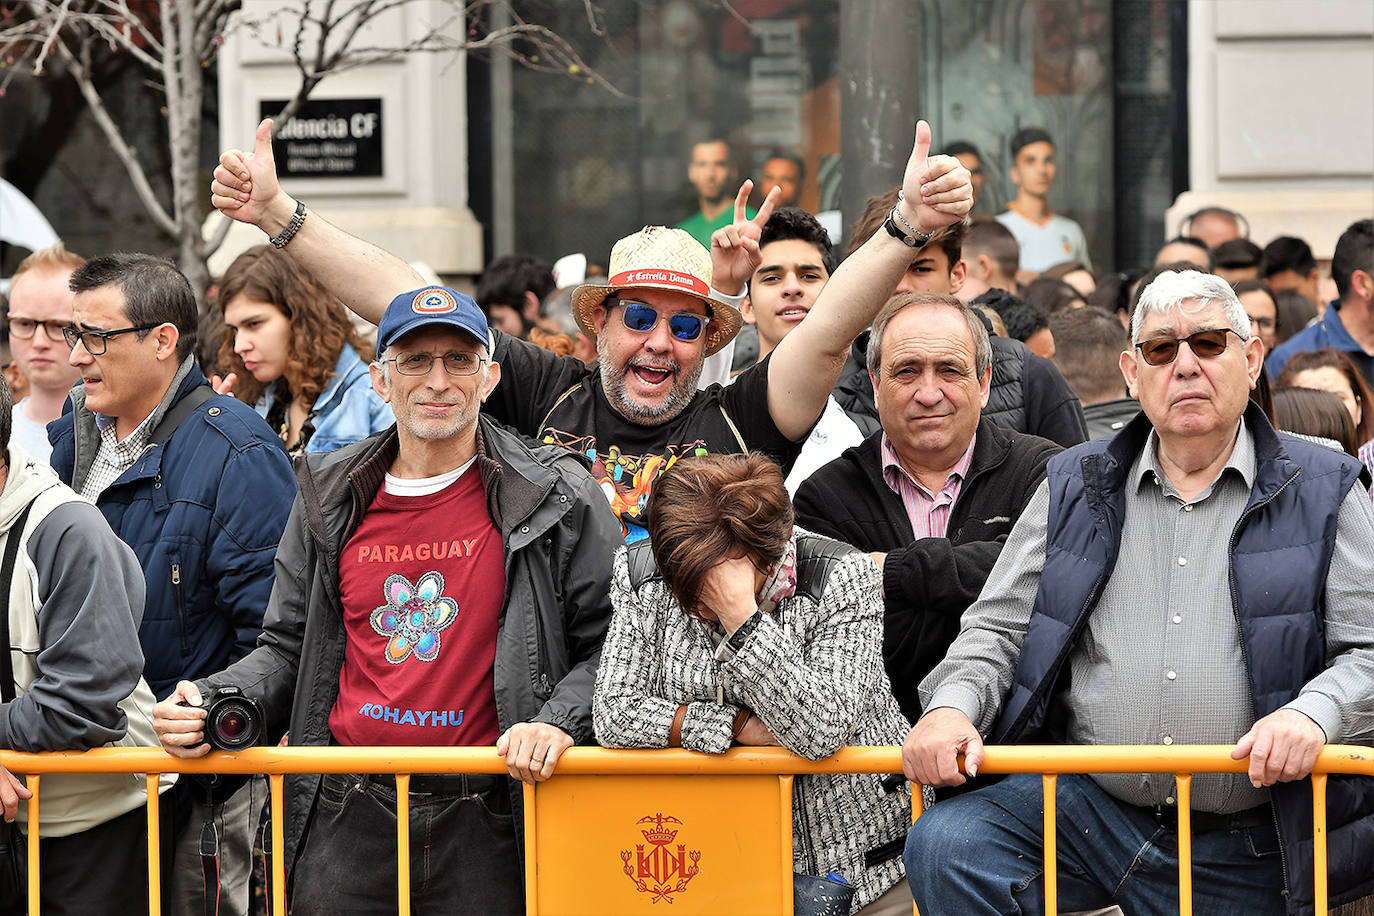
[796,417,1061,722]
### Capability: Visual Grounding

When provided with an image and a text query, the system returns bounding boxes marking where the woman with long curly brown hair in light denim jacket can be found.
[218,244,394,456]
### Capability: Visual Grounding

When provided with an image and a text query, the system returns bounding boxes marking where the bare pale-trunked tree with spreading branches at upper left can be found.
[0,0,626,293]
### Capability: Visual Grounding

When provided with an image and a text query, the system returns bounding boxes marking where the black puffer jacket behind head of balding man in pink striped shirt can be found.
[834,331,1088,448]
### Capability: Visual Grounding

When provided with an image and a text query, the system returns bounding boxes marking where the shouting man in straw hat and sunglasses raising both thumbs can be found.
[210,121,973,541]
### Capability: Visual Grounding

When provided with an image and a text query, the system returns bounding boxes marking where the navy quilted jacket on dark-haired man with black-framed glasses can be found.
[48,357,295,699]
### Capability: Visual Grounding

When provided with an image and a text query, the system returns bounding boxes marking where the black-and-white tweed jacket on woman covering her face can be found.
[592,530,911,911]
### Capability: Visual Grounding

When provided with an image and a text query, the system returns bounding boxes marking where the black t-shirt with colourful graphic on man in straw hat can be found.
[484,331,805,542]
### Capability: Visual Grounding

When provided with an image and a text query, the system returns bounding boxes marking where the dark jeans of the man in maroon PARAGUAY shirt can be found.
[287,773,525,916]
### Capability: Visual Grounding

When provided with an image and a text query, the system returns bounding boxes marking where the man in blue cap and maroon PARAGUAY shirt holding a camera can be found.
[154,287,620,915]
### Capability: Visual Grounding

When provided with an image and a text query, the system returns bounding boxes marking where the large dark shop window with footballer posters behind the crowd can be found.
[494,0,1182,271]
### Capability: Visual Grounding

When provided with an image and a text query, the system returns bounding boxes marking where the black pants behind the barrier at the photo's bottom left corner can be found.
[3,805,148,916]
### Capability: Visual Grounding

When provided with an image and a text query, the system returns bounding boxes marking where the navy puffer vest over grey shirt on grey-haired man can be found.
[992,404,1374,913]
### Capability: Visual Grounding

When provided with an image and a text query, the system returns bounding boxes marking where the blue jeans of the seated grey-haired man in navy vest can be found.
[905,773,1285,916]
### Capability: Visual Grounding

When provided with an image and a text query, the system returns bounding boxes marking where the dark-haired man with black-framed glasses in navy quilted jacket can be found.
[48,254,295,913]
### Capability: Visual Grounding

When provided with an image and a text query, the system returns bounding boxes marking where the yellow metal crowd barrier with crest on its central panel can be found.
[0,746,1374,916]
